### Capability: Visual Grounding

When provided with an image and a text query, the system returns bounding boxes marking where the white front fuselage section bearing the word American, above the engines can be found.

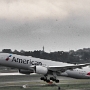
[0,53,72,69]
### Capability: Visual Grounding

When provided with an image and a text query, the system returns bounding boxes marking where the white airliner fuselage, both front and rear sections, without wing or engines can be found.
[0,53,90,78]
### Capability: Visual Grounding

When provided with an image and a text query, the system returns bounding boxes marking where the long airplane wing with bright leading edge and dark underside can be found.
[48,63,90,72]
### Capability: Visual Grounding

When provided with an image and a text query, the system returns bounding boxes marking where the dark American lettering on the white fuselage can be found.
[12,57,42,65]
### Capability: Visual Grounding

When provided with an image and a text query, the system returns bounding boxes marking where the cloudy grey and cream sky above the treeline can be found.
[0,0,90,52]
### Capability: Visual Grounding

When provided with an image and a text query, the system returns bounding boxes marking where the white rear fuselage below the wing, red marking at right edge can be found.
[58,66,90,79]
